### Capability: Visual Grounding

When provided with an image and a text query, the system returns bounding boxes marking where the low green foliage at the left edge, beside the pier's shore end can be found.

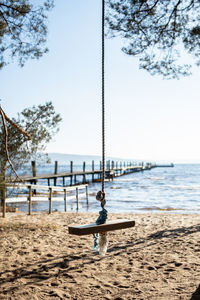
[0,102,61,173]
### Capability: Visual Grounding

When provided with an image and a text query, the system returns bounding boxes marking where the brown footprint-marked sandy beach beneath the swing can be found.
[0,212,200,300]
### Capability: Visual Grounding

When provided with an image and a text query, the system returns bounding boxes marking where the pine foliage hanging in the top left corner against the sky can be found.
[0,0,53,69]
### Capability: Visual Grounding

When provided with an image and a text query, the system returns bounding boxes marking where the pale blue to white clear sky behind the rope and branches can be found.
[0,0,200,162]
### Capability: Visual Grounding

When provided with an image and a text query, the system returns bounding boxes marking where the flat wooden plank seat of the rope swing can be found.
[68,219,135,235]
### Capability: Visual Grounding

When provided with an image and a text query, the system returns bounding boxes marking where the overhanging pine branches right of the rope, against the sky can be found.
[106,0,200,78]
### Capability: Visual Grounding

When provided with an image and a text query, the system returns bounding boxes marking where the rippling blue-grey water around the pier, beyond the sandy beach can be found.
[9,164,200,214]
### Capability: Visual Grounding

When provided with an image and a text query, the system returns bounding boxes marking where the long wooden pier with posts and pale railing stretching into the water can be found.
[2,161,174,217]
